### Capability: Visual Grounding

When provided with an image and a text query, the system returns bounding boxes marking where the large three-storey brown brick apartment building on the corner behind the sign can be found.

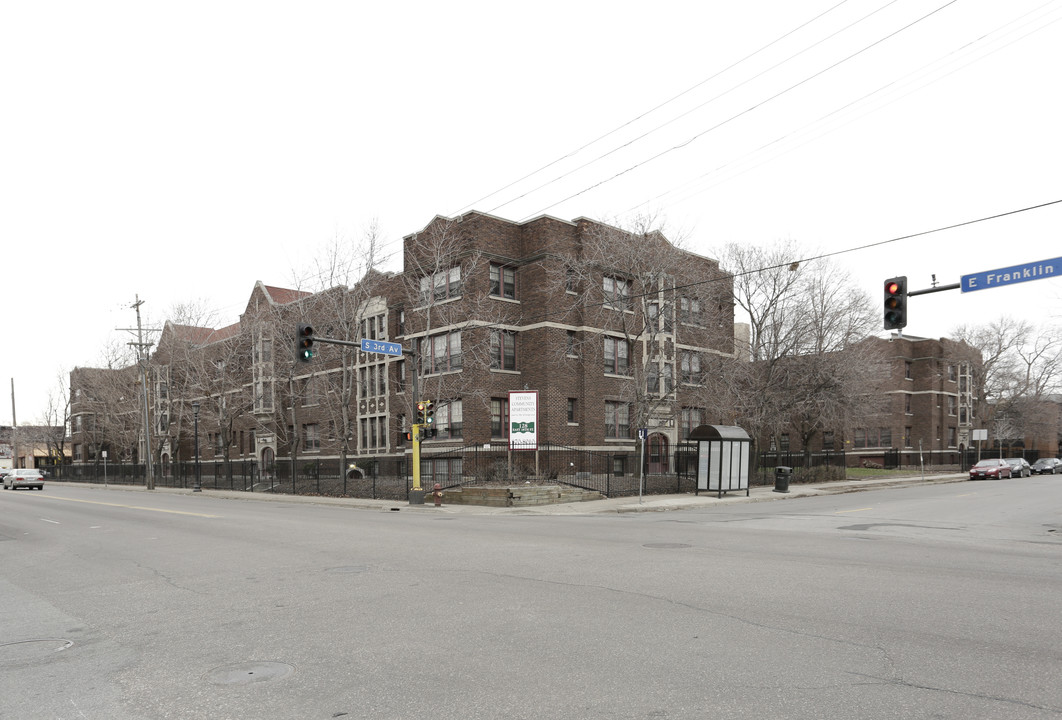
[64,212,734,480]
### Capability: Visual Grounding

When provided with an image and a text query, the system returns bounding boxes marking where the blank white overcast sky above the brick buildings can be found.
[0,0,1062,425]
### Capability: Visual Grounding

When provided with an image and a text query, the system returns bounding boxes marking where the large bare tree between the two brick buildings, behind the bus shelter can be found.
[712,240,881,452]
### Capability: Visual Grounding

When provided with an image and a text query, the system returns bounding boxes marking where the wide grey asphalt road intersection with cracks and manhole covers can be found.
[0,477,1062,720]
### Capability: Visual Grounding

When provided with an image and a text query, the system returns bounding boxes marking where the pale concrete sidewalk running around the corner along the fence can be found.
[58,473,969,515]
